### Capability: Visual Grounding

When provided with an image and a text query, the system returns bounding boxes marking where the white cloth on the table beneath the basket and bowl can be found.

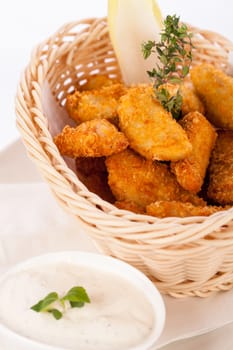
[0,143,233,350]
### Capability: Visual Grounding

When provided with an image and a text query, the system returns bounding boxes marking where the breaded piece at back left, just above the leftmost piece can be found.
[66,84,126,123]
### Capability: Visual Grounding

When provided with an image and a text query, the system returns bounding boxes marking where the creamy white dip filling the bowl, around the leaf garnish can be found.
[0,262,155,350]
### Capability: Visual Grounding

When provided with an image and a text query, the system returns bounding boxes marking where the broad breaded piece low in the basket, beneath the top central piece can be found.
[105,149,205,207]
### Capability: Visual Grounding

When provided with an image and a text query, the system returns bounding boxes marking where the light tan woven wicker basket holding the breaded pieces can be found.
[16,15,233,297]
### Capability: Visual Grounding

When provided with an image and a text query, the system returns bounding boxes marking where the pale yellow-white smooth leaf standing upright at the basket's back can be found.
[108,0,162,84]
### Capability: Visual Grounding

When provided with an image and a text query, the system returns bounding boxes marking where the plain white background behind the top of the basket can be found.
[0,0,233,150]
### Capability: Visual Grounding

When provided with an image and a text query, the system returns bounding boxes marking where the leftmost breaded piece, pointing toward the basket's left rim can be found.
[54,119,128,158]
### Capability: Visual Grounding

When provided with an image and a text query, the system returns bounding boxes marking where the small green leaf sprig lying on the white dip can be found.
[31,286,91,320]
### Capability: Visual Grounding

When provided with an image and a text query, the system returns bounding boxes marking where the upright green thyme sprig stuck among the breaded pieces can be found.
[142,15,193,119]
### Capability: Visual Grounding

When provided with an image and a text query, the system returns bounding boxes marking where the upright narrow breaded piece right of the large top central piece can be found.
[171,112,217,193]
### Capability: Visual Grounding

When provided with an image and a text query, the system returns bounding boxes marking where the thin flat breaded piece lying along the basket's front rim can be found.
[146,201,224,218]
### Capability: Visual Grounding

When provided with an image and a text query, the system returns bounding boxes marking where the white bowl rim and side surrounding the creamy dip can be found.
[0,252,165,350]
